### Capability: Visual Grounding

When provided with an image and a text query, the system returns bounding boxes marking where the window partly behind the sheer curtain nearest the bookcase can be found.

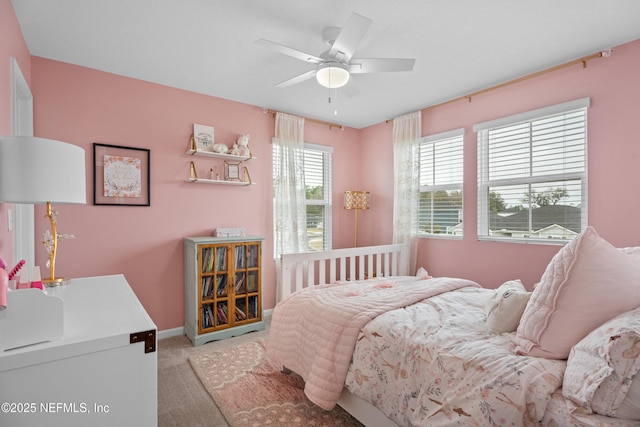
[273,143,333,251]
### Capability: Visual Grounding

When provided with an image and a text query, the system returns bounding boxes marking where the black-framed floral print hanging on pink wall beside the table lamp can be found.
[93,142,151,206]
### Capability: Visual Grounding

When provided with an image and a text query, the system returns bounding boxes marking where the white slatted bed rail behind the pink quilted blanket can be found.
[277,243,409,302]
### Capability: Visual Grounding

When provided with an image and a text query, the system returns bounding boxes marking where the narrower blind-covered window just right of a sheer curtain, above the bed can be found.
[418,129,464,236]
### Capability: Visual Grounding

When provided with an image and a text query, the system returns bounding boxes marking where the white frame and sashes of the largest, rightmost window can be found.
[473,97,591,245]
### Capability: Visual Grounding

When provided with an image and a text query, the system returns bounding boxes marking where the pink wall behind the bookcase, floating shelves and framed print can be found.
[32,57,360,330]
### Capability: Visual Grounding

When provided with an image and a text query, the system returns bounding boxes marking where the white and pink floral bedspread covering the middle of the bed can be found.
[346,288,566,427]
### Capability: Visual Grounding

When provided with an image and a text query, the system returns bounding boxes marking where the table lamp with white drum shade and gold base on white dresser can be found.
[0,136,86,287]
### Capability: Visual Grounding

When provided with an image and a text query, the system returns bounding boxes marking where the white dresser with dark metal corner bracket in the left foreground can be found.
[0,275,158,426]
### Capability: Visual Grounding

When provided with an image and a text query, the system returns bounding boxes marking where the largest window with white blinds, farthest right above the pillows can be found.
[474,98,589,242]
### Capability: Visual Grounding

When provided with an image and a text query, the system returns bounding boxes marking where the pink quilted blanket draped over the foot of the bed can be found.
[267,276,480,410]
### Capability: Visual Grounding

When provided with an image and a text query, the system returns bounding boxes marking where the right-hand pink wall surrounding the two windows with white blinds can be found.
[362,41,640,287]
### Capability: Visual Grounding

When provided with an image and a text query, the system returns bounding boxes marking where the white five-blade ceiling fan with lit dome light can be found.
[256,13,416,89]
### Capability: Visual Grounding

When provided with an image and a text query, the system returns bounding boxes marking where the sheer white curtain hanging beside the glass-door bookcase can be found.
[273,113,308,258]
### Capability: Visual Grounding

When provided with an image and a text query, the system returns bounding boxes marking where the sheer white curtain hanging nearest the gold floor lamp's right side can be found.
[393,111,422,273]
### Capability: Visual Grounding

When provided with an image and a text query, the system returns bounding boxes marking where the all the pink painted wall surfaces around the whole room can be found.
[5,0,640,330]
